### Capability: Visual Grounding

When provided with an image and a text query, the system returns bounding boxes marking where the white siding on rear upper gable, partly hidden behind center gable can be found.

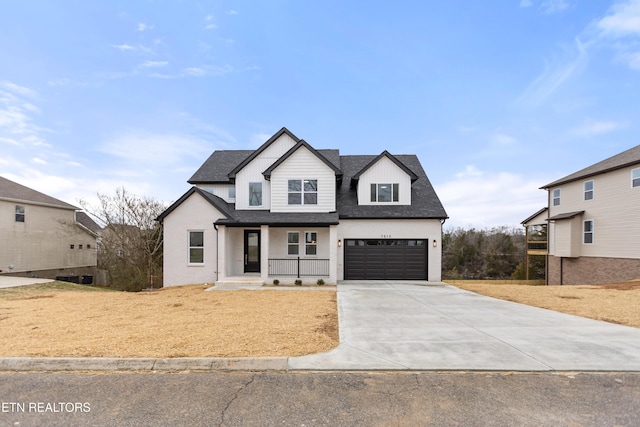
[236,134,296,210]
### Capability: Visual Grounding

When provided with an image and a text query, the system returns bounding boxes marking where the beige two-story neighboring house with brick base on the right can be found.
[538,145,640,285]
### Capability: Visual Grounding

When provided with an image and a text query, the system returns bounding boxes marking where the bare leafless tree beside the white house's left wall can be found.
[80,187,166,291]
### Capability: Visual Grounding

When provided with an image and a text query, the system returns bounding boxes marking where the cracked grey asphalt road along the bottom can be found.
[0,371,640,427]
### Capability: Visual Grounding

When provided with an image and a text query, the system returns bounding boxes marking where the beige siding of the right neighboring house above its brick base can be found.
[550,166,640,258]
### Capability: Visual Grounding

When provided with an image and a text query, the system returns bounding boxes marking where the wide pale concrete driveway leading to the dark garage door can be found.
[289,282,640,371]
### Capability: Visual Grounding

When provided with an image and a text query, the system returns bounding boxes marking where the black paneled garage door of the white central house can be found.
[344,239,427,280]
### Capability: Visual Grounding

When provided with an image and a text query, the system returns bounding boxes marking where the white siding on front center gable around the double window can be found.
[271,147,336,212]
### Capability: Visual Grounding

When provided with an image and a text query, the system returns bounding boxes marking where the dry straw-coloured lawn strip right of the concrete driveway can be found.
[454,280,640,328]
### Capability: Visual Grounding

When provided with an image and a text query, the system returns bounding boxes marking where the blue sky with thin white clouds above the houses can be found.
[0,0,640,227]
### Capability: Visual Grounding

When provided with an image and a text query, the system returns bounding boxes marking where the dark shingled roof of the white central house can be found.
[158,128,448,226]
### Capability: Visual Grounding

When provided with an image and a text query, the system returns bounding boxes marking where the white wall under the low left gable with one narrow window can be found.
[163,193,223,286]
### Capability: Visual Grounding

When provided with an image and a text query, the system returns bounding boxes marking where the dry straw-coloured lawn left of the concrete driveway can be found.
[0,282,338,357]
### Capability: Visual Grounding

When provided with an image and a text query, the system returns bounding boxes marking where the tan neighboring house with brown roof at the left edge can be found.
[0,177,100,278]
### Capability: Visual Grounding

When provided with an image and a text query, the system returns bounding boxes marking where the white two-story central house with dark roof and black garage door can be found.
[158,128,447,286]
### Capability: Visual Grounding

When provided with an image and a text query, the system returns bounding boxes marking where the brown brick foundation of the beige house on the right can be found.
[547,256,640,285]
